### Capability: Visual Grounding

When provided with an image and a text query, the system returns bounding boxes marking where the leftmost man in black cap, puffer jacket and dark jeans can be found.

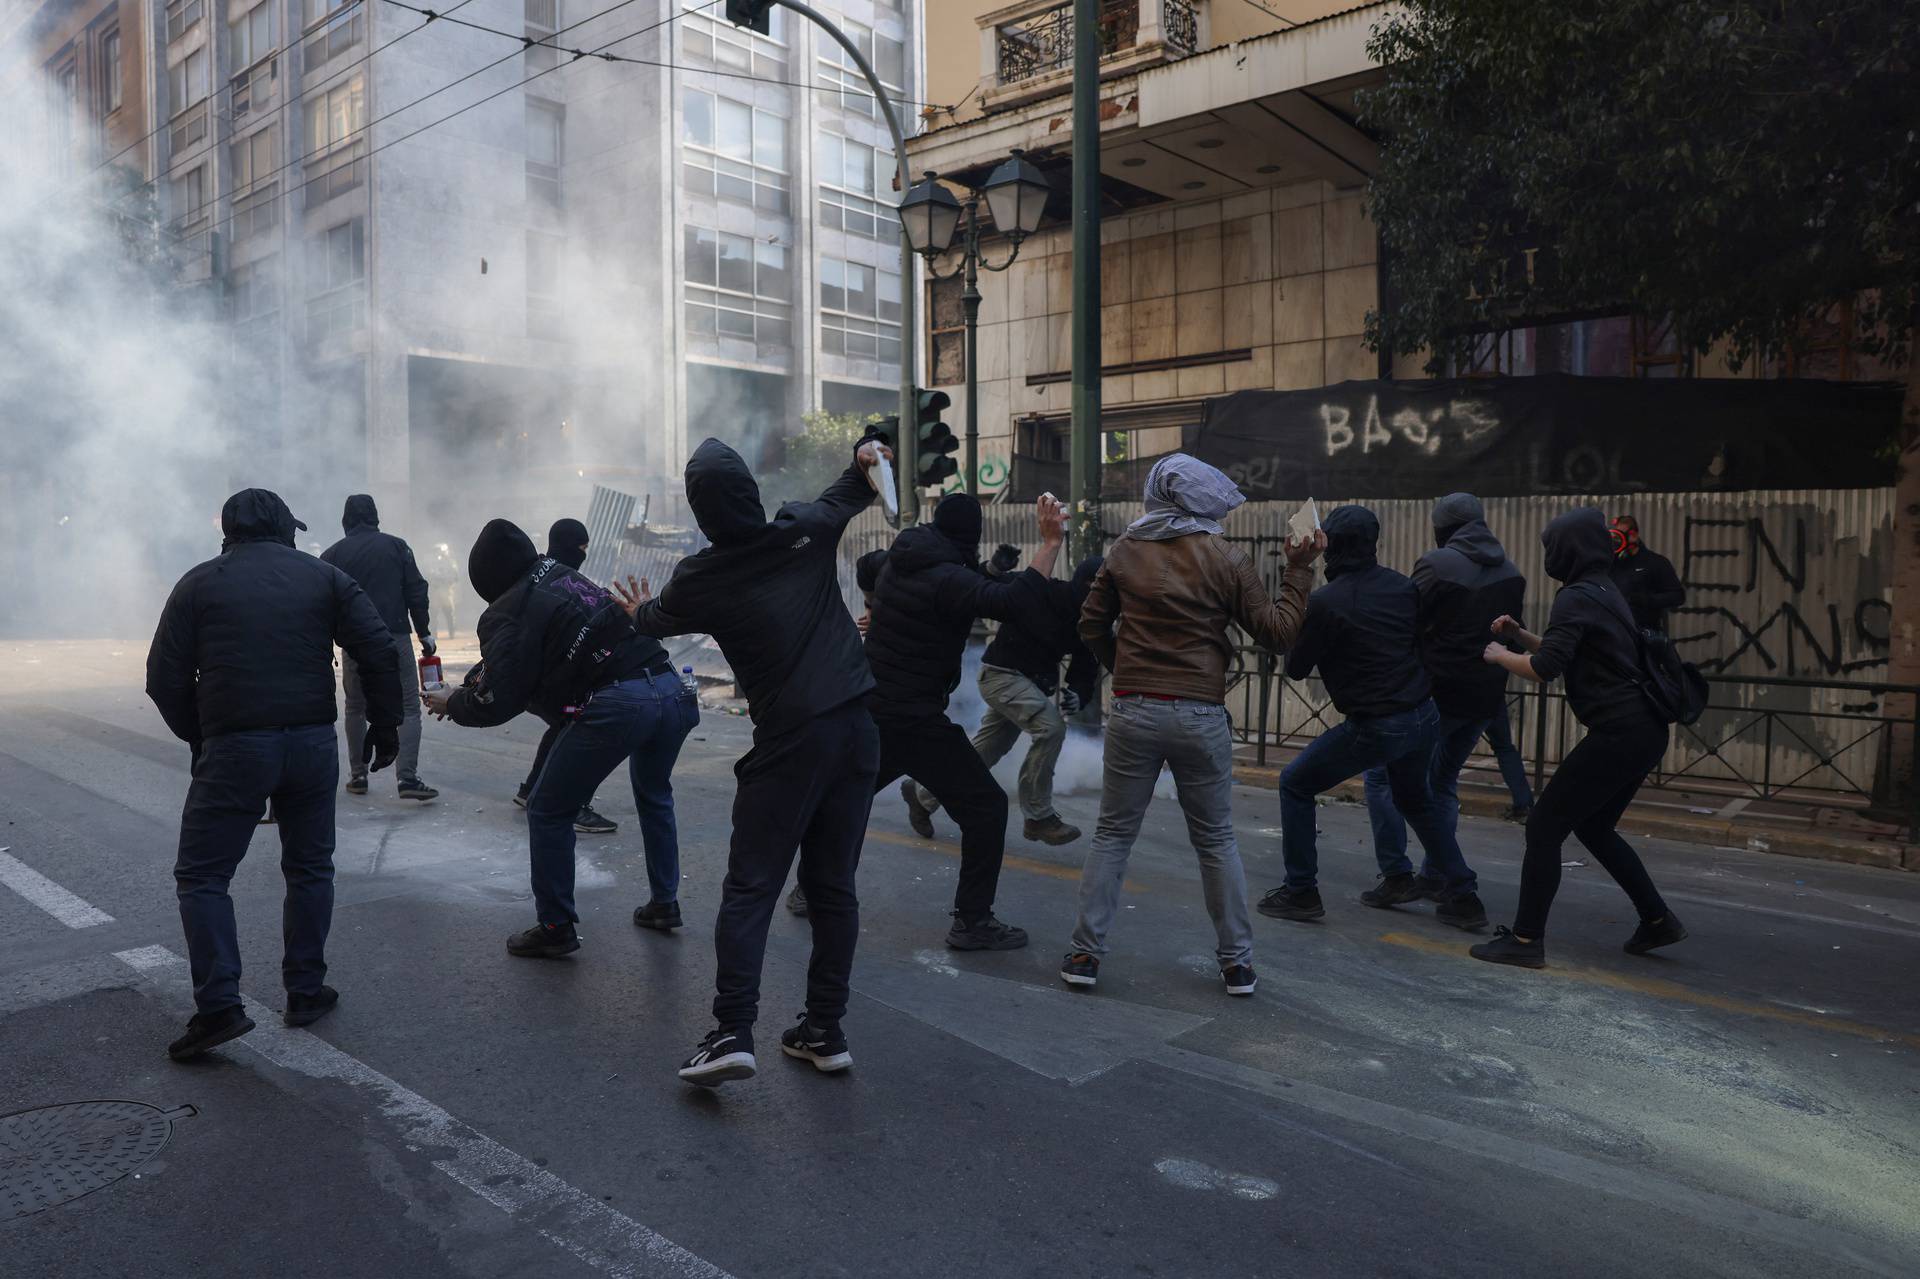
[146,488,401,1060]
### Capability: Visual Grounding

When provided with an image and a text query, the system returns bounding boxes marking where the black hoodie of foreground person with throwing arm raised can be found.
[634,440,874,737]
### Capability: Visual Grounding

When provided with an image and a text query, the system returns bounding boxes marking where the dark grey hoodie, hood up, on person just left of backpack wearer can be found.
[1413,494,1526,720]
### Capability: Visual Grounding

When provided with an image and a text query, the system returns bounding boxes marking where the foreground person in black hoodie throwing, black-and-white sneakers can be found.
[622,436,891,1087]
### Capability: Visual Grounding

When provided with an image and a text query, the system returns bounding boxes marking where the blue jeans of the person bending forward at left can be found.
[526,672,701,924]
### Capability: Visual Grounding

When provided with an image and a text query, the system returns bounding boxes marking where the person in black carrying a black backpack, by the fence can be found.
[1471,507,1688,968]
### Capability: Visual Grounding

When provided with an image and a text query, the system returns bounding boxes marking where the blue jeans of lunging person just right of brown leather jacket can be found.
[1281,701,1475,891]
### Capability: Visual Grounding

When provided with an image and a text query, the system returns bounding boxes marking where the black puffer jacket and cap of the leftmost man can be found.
[146,488,401,749]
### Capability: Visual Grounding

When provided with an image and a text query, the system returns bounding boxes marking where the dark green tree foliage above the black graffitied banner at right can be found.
[1361,0,1920,367]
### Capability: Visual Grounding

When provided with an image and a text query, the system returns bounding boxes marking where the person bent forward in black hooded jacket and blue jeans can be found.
[426,520,699,958]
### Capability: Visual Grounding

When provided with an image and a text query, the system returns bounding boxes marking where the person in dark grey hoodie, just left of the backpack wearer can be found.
[1367,494,1526,906]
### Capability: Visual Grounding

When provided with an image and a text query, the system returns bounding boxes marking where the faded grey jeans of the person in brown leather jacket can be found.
[1073,697,1254,968]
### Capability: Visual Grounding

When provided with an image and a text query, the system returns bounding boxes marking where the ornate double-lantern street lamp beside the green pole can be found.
[900,152,1050,494]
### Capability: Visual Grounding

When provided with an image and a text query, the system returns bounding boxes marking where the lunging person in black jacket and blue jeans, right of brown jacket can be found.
[1260,507,1486,929]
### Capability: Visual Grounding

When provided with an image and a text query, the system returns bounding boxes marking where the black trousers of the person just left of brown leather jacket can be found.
[875,714,1006,924]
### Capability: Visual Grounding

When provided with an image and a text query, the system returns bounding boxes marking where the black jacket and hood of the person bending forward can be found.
[447,520,668,728]
